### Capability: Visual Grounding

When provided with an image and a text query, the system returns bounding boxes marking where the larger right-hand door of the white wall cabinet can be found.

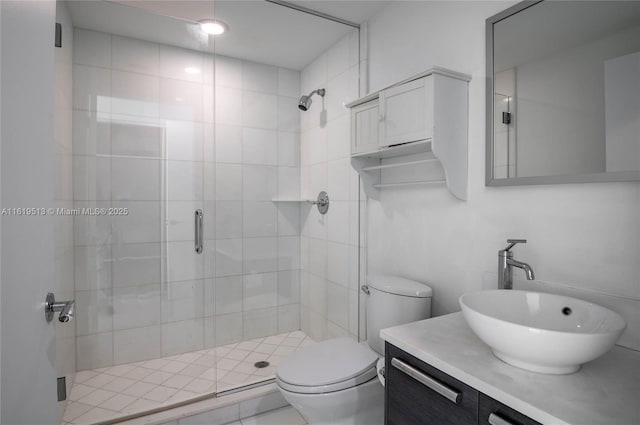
[380,76,433,147]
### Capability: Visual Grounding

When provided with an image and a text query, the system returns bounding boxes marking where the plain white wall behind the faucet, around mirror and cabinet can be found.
[367,1,640,349]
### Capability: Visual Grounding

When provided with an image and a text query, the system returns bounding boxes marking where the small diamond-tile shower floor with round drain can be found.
[62,331,313,425]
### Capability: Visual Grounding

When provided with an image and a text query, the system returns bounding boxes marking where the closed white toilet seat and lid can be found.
[276,338,378,394]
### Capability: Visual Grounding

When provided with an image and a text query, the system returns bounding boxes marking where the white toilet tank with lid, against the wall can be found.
[367,275,432,355]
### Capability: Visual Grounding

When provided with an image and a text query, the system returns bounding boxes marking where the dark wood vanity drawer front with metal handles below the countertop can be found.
[384,343,541,425]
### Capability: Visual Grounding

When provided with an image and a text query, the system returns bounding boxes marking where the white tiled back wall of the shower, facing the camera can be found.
[73,29,300,370]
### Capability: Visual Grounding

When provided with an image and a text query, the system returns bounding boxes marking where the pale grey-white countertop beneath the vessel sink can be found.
[380,313,640,425]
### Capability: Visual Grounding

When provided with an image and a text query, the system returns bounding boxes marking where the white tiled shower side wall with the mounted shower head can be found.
[300,30,360,340]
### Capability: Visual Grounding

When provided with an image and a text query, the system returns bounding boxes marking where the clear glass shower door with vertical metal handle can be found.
[63,1,216,423]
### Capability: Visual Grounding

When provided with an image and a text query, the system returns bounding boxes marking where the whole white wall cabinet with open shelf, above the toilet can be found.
[347,68,471,199]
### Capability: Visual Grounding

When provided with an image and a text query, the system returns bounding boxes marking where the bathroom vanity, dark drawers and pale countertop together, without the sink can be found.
[380,313,640,425]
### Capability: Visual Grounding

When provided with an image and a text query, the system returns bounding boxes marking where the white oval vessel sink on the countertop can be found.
[460,290,626,374]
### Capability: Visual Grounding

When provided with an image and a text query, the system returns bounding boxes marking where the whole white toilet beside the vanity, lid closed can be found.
[276,276,432,425]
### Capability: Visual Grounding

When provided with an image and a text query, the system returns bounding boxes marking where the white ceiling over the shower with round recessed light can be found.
[67,0,389,70]
